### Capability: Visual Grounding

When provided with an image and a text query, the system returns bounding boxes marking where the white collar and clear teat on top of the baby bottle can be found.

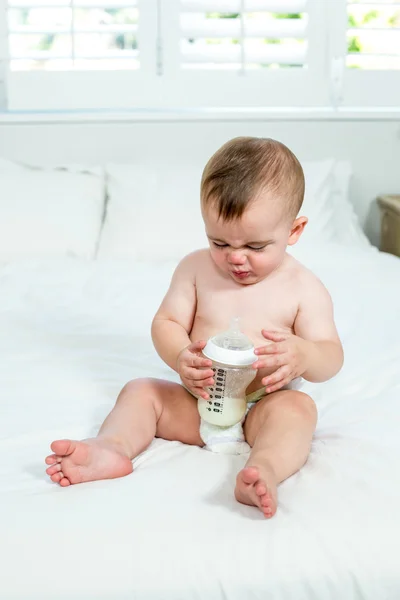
[203,317,257,367]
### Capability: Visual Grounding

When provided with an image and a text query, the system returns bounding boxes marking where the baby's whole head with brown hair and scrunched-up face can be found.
[201,137,307,284]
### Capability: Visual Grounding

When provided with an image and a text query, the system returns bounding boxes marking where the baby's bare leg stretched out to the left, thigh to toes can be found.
[46,379,204,487]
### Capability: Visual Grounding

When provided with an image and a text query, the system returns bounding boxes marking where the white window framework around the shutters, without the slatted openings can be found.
[0,0,400,113]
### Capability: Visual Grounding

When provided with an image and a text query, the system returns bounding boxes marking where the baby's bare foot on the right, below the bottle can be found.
[235,467,277,519]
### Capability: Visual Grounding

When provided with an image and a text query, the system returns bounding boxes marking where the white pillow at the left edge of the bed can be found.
[0,160,104,261]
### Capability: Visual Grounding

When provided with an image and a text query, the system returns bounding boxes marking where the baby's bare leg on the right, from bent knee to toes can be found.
[235,390,317,517]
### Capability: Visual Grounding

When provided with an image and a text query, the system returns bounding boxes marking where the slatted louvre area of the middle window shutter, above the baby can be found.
[180,0,308,69]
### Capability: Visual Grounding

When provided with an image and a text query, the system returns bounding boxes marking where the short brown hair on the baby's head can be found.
[201,137,305,221]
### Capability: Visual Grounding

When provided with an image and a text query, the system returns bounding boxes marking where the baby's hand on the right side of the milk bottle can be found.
[253,329,307,394]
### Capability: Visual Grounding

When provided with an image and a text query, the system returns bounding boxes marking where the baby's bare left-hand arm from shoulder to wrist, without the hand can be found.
[151,254,196,371]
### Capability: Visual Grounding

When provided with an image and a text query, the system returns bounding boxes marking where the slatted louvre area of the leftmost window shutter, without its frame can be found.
[8,0,140,71]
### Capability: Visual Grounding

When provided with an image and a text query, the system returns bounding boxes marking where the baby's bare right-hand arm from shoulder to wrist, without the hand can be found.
[294,272,343,382]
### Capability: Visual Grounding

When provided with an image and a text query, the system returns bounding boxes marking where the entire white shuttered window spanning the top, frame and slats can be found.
[0,0,400,110]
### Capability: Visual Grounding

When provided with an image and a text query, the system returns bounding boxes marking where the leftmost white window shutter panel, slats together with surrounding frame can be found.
[6,0,158,110]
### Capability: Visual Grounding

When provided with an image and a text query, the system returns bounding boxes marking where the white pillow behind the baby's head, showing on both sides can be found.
[98,159,368,260]
